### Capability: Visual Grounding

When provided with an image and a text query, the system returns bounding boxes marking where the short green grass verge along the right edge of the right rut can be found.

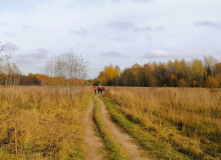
[102,98,190,160]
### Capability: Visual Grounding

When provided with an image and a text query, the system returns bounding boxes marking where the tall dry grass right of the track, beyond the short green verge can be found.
[105,87,221,159]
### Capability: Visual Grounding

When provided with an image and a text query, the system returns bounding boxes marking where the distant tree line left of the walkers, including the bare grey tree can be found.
[0,43,87,86]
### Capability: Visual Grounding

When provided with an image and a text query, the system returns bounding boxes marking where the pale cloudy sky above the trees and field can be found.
[0,0,221,78]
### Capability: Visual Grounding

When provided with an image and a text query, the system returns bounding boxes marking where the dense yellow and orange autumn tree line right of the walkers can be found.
[96,56,221,88]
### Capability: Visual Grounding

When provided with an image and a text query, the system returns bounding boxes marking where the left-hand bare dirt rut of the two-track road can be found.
[84,98,104,160]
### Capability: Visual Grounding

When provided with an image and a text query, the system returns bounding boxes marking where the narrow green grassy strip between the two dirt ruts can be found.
[94,99,129,160]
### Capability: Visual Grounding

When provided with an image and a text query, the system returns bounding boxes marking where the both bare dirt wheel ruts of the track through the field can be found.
[84,97,149,160]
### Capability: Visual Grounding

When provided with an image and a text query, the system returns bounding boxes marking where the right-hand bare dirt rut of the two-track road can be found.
[97,98,149,160]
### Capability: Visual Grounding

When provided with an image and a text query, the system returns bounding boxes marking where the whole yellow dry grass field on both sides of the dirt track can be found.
[0,86,221,160]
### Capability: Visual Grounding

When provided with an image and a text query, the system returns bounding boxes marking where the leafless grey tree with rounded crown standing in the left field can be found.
[45,50,87,96]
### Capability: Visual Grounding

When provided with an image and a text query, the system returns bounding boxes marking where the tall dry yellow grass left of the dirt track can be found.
[0,86,88,160]
